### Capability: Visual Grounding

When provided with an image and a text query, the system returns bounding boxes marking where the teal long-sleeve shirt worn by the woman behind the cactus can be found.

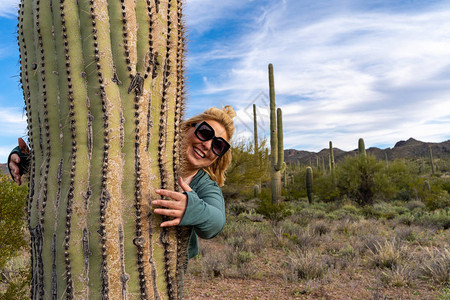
[179,170,225,258]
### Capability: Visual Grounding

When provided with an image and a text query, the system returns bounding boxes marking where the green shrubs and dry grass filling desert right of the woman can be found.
[181,141,450,299]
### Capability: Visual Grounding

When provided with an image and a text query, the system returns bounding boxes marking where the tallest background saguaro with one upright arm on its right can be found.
[269,64,286,203]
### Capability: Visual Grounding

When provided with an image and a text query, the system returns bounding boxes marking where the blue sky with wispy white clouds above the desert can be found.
[0,0,450,162]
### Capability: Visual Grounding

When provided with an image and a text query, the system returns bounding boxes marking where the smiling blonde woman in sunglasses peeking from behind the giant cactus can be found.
[8,106,236,258]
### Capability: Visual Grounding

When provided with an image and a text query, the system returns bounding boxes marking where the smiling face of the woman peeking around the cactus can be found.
[185,120,228,169]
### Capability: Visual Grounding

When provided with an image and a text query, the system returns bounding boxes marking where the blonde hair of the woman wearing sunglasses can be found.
[181,105,236,186]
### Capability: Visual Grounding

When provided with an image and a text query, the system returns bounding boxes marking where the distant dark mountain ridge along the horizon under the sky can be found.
[284,138,450,164]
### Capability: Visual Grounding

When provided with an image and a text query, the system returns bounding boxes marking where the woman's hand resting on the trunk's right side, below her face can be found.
[152,177,192,227]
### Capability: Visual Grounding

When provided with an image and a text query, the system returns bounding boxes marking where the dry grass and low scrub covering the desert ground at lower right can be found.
[186,200,450,299]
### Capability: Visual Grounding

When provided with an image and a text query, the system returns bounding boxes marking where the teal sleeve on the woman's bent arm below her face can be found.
[180,183,225,239]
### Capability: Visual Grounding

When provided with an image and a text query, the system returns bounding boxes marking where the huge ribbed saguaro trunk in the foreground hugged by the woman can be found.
[18,0,189,299]
